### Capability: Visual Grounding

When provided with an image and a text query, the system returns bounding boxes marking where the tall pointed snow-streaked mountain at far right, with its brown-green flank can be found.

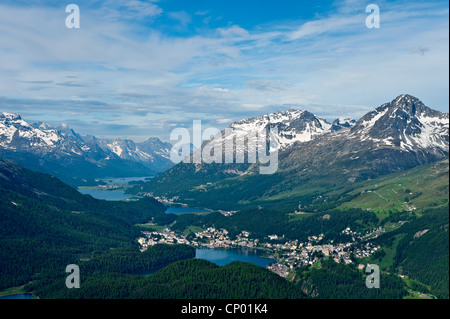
[280,94,449,182]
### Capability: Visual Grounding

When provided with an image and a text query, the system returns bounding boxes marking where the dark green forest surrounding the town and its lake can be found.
[0,160,449,299]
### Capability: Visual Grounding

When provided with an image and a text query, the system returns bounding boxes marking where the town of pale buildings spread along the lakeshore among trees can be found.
[138,222,385,277]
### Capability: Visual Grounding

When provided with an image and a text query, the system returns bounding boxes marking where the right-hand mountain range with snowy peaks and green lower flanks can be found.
[131,94,449,209]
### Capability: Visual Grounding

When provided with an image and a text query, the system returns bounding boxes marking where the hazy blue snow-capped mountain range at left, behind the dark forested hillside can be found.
[0,113,173,185]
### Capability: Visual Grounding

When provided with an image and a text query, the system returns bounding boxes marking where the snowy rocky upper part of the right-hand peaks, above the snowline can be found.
[197,94,449,164]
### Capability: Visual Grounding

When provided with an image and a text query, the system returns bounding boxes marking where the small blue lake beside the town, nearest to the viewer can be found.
[195,248,275,267]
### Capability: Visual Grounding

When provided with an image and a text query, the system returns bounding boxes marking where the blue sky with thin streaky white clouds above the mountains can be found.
[0,0,449,141]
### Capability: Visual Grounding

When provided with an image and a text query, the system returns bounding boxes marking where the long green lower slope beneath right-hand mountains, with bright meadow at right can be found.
[134,154,449,212]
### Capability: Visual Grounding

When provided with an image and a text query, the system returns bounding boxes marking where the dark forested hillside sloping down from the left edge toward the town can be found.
[0,160,176,289]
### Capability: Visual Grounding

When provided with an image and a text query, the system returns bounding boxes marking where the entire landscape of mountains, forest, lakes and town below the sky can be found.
[0,94,449,299]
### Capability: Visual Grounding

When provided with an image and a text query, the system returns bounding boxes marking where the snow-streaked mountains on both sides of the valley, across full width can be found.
[0,94,449,192]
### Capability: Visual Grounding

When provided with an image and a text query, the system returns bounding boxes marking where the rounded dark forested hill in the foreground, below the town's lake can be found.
[30,259,305,299]
